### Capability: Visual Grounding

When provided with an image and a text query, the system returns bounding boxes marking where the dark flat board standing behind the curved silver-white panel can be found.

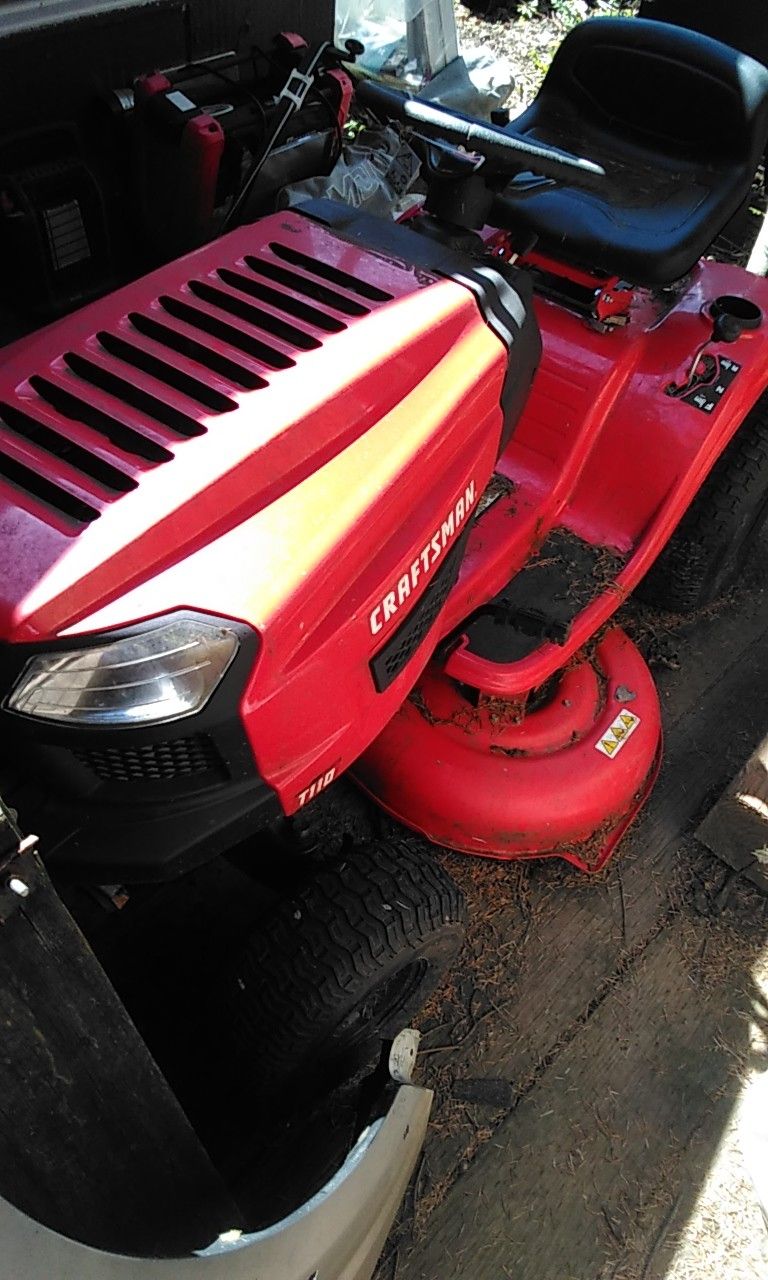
[0,854,238,1256]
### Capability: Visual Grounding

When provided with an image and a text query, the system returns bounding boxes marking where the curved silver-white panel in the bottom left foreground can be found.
[0,1084,433,1280]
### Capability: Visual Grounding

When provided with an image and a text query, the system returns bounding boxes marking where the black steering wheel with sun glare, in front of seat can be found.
[357,81,605,187]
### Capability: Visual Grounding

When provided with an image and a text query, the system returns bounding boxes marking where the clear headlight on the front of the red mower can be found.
[6,618,238,727]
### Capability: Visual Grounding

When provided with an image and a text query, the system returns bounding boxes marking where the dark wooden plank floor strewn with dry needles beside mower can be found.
[378,555,768,1280]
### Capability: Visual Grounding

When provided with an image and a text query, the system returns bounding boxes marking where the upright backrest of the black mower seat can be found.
[536,18,768,172]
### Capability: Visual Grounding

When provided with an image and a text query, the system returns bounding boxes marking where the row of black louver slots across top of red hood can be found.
[0,225,392,532]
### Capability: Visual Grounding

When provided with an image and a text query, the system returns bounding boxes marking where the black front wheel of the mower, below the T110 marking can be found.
[233,840,466,1098]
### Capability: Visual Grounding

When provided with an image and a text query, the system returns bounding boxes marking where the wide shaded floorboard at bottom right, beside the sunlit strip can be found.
[397,890,764,1280]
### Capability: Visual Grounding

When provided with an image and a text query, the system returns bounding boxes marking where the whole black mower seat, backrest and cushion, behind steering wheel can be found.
[507,18,768,285]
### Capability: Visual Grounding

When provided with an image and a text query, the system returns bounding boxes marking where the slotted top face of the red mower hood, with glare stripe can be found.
[0,212,468,641]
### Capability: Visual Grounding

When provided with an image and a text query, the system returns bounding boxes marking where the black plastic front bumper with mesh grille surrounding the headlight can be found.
[0,611,283,884]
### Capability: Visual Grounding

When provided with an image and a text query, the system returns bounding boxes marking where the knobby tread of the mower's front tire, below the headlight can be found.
[233,840,466,1084]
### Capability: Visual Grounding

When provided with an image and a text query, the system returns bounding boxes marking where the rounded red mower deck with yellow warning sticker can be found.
[355,628,660,872]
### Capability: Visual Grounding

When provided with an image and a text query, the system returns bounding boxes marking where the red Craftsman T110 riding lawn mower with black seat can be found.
[0,7,768,1162]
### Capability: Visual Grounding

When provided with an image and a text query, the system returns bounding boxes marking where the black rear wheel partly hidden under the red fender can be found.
[636,381,768,613]
